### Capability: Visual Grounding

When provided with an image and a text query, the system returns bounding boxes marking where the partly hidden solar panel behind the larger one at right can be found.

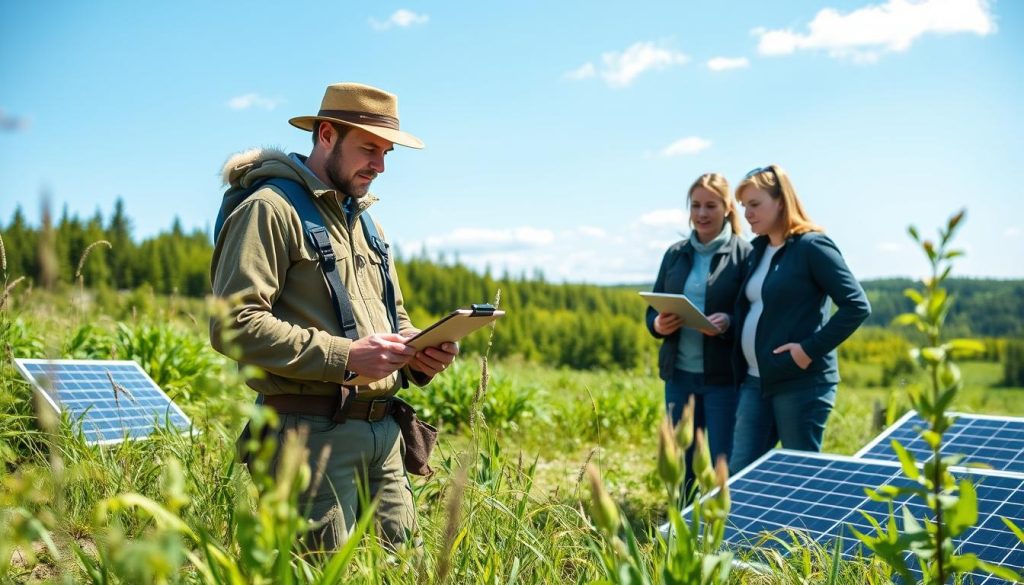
[855,411,1024,473]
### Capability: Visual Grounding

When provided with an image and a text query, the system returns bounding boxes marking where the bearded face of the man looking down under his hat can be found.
[327,128,394,199]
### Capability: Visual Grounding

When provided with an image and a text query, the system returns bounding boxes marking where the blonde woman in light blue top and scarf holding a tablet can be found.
[647,173,751,495]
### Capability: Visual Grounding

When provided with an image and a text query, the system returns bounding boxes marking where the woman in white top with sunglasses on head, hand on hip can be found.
[729,165,871,473]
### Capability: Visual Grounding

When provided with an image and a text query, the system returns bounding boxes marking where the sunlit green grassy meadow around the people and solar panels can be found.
[0,280,1024,584]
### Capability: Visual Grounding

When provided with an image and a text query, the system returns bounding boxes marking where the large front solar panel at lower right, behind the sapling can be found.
[684,450,1024,585]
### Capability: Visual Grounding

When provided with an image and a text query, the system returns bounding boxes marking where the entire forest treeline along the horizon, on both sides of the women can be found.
[0,201,1024,369]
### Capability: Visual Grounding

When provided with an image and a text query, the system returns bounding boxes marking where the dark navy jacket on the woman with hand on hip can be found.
[733,232,871,395]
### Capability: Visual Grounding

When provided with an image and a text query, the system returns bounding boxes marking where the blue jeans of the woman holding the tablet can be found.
[665,370,737,495]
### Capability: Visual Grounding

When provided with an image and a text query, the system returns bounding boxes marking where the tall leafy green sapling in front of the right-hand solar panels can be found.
[851,211,1020,585]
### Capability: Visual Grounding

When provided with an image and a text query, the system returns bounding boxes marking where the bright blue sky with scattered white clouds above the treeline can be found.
[0,0,1024,283]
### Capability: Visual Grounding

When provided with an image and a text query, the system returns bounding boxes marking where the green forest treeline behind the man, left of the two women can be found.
[0,201,656,369]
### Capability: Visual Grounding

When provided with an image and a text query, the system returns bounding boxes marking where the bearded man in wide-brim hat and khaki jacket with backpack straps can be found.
[211,83,458,549]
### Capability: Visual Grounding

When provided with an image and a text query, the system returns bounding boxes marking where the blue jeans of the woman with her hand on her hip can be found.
[729,376,836,475]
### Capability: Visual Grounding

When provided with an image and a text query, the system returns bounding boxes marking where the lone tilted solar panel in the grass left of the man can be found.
[14,359,191,445]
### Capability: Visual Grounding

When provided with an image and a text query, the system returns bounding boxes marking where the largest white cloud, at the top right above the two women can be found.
[753,0,995,64]
